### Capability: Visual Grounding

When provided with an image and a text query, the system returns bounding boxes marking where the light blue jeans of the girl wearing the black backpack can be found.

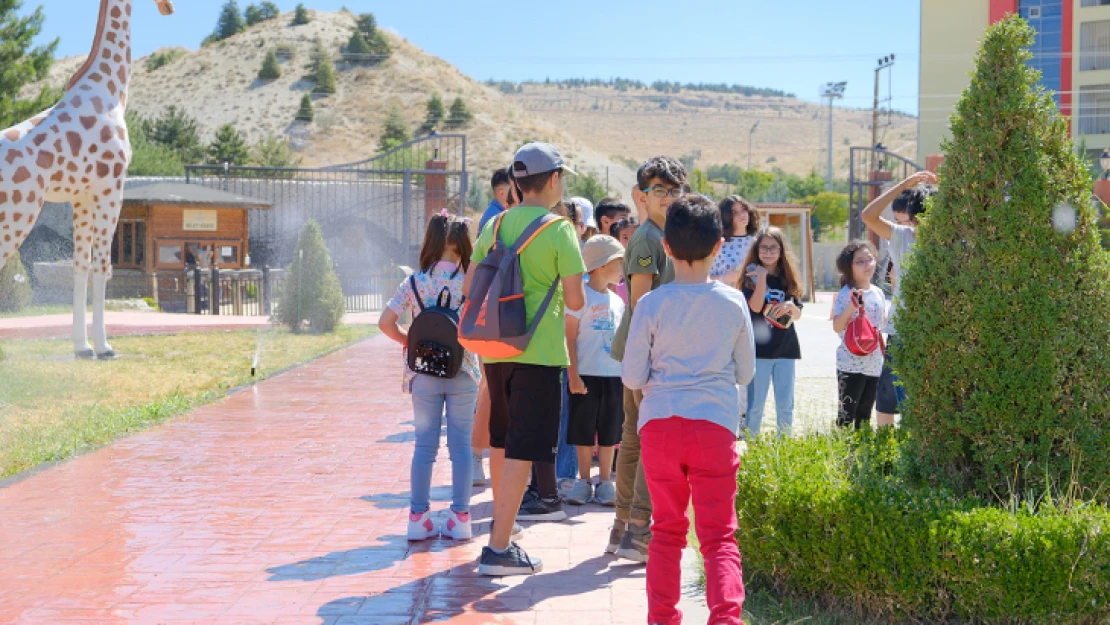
[410,372,478,514]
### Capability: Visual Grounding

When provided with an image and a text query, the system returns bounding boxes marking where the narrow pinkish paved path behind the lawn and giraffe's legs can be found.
[0,311,381,340]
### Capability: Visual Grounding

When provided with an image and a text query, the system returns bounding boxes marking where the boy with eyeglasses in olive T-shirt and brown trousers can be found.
[605,157,686,563]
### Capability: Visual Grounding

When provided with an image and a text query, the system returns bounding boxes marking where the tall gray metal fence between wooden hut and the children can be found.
[185,134,467,280]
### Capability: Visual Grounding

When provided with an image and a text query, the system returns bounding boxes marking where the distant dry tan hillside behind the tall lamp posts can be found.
[506,84,917,177]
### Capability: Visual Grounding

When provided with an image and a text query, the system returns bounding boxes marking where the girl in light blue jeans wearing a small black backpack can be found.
[377,211,482,541]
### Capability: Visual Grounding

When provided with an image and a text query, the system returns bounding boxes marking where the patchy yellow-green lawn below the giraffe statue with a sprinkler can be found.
[0,325,376,477]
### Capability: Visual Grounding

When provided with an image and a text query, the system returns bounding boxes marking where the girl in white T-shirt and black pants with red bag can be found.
[833,241,887,430]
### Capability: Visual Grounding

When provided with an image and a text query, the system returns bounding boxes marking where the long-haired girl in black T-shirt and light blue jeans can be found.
[737,228,801,438]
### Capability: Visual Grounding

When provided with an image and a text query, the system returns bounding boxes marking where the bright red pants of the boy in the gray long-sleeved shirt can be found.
[640,416,744,625]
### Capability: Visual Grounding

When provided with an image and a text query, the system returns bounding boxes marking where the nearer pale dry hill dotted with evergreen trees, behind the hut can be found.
[30,11,635,190]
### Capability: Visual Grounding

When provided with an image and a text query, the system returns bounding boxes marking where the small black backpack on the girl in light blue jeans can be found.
[408,276,465,380]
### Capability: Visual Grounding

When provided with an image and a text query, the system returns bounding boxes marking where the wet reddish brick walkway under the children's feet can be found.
[0,337,706,625]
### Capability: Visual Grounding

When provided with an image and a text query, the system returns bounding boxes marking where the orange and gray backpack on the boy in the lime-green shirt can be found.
[458,213,562,359]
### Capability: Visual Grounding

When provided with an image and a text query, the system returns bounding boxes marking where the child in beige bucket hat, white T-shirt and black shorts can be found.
[566,234,625,506]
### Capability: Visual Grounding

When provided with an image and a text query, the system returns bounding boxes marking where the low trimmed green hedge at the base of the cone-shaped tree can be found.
[736,430,1110,624]
